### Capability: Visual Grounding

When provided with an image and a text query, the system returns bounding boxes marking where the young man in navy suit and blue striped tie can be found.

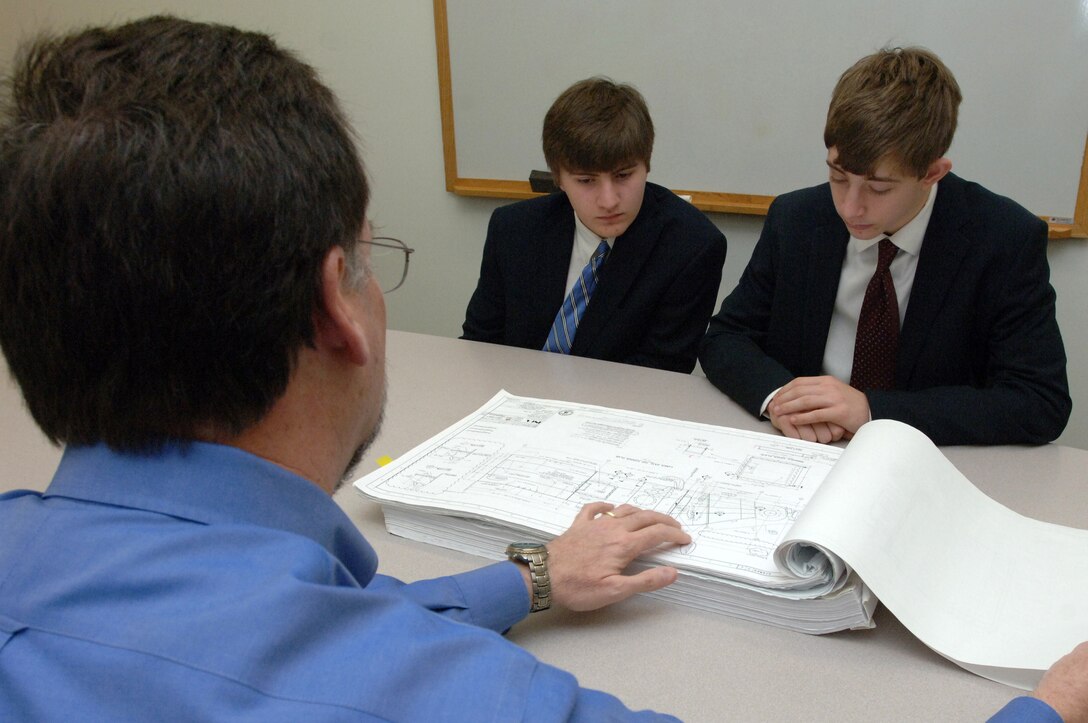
[461,78,726,373]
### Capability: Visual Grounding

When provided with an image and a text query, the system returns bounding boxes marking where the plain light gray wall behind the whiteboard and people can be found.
[0,0,1088,449]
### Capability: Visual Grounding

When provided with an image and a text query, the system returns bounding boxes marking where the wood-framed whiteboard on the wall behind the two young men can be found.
[435,0,1088,235]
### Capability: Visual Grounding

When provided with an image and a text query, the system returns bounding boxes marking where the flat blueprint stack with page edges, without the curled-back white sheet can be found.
[356,391,877,633]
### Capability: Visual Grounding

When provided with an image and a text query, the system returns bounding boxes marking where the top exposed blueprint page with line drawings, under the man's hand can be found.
[357,391,842,588]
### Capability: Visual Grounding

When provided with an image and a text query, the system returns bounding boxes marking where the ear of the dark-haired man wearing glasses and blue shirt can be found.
[313,245,370,366]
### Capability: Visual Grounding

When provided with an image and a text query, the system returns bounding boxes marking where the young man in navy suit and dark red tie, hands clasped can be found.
[700,48,1072,445]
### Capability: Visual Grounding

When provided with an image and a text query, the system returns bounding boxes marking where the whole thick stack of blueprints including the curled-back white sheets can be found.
[355,391,1088,687]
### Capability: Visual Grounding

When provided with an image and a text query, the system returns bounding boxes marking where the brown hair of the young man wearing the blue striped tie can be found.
[542,77,654,178]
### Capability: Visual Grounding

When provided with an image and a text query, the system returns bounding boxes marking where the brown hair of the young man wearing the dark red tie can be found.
[824,48,962,178]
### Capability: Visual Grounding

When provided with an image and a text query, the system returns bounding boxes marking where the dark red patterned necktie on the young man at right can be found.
[850,238,899,390]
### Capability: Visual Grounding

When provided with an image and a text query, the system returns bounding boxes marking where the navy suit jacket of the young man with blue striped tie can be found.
[461,183,726,373]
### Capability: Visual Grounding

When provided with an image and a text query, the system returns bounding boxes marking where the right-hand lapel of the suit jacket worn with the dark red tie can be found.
[895,174,970,382]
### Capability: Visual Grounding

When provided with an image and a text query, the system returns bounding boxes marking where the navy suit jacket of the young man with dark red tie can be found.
[700,174,1073,445]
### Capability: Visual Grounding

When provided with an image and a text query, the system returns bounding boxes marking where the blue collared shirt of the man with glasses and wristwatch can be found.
[0,442,670,722]
